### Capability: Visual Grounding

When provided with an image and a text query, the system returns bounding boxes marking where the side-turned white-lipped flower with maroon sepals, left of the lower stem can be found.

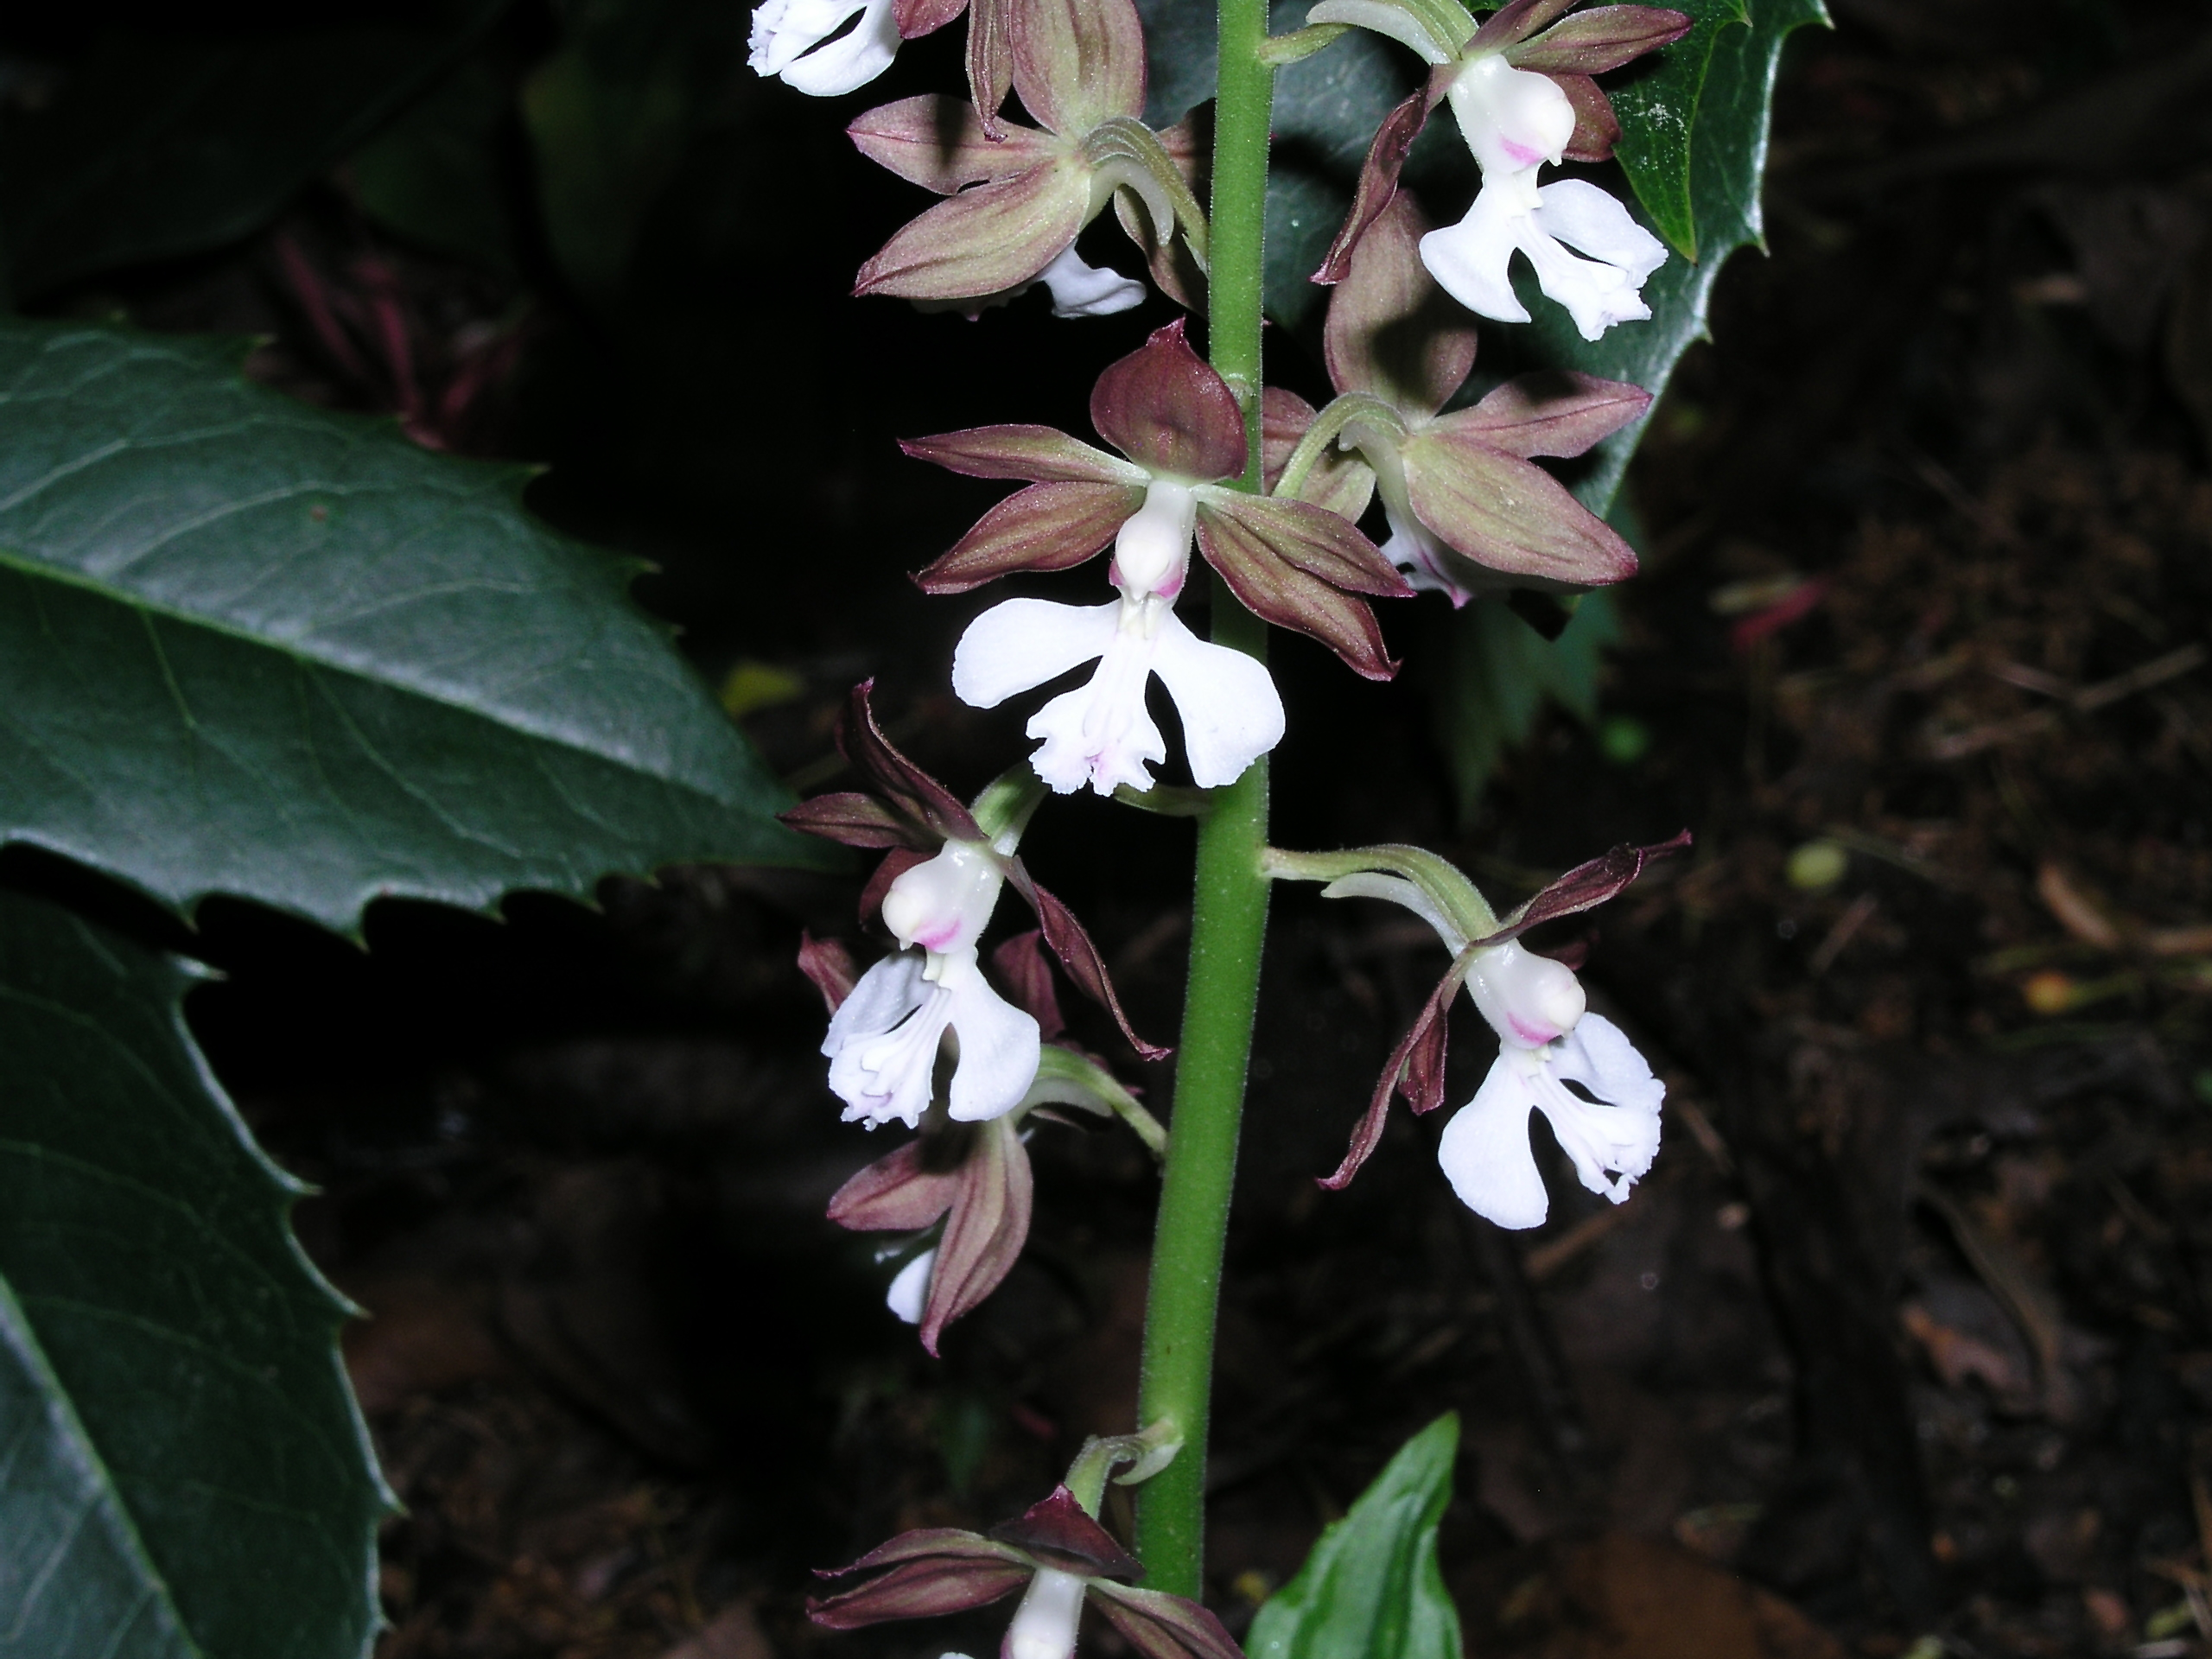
[783,681,1166,1128]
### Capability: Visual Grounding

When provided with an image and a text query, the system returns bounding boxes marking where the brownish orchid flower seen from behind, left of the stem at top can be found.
[842,0,1205,316]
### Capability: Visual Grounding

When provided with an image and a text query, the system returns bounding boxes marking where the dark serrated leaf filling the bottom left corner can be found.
[0,896,390,1659]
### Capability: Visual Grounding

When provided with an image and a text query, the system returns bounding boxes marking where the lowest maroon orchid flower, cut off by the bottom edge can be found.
[807,1486,1243,1659]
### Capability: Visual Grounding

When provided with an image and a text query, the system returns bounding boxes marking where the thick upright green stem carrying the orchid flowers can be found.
[1137,0,1274,1597]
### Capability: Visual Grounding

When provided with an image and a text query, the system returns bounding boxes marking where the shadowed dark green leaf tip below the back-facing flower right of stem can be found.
[1435,588,1621,818]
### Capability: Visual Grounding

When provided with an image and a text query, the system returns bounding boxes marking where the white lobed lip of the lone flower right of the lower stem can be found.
[1435,1013,1666,1228]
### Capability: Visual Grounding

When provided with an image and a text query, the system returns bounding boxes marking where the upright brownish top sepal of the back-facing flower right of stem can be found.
[1320,194,1476,416]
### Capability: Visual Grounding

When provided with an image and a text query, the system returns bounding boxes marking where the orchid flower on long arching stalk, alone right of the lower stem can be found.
[1269,830,1690,1228]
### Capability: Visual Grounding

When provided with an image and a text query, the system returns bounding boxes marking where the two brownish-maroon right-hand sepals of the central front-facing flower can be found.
[1199,495,1411,679]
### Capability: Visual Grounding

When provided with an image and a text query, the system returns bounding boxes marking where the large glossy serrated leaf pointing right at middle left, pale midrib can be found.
[0,321,825,929]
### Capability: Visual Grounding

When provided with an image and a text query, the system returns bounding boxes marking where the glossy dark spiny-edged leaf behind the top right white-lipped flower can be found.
[1520,0,1827,513]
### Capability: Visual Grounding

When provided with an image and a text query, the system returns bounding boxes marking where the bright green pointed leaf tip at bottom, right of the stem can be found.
[1245,1411,1460,1659]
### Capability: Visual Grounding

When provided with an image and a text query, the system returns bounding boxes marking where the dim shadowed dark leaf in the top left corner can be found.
[0,0,506,299]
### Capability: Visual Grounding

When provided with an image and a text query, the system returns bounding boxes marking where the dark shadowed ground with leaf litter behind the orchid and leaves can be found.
[0,0,2212,1659]
